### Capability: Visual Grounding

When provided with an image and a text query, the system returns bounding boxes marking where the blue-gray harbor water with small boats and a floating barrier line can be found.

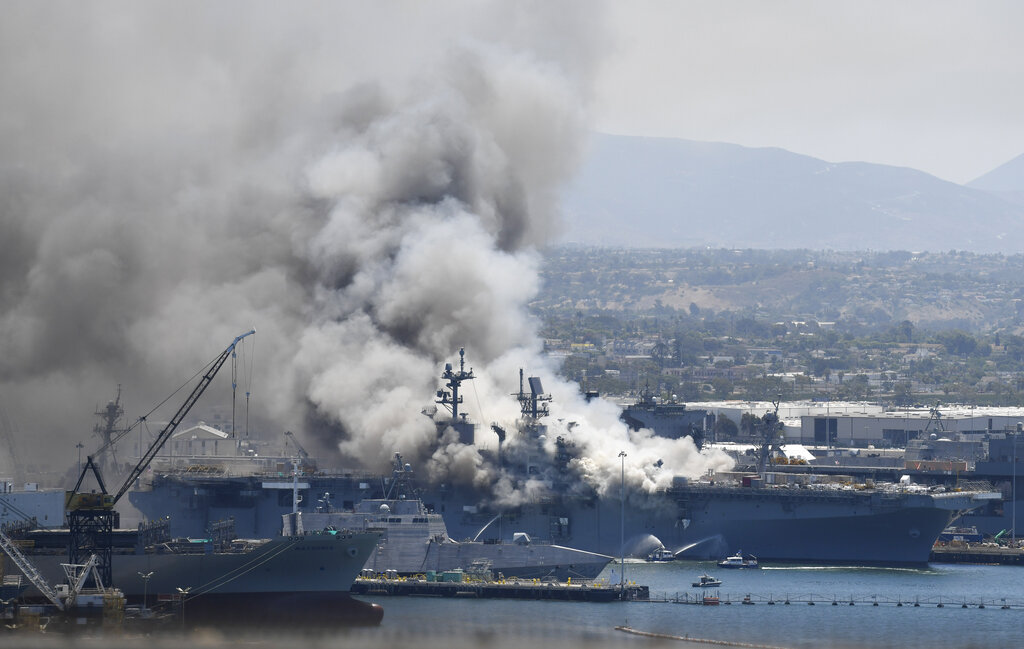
[362,561,1024,649]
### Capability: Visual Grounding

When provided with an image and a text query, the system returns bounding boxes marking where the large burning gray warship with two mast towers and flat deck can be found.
[129,351,998,565]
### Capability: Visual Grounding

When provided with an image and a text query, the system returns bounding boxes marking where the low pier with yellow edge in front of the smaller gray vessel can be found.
[351,577,649,602]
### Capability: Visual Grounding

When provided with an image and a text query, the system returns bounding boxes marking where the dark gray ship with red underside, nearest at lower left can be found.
[12,519,383,626]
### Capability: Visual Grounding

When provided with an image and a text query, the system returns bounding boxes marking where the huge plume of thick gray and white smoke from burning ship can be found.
[0,2,729,493]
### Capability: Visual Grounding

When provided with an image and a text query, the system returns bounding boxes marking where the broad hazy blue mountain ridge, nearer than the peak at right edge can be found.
[562,135,1024,253]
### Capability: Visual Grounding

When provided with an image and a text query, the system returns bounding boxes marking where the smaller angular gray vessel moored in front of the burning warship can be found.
[283,453,613,580]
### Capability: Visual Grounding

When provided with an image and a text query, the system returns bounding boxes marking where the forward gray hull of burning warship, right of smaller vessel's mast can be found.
[417,486,981,564]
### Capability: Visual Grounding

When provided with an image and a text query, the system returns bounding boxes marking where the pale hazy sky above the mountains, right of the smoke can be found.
[593,0,1024,182]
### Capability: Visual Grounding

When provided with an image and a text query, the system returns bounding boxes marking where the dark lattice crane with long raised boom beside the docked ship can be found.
[65,330,256,583]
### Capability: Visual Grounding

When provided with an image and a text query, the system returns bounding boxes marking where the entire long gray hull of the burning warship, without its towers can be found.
[130,475,982,565]
